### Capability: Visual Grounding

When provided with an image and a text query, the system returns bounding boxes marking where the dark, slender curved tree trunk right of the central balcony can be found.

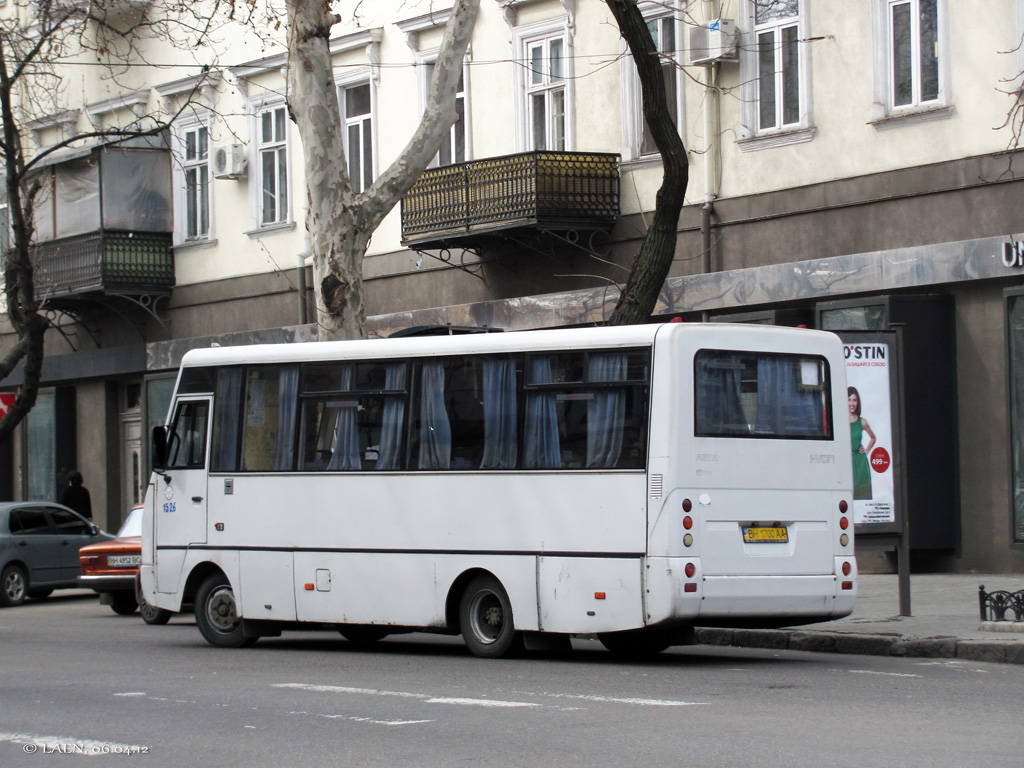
[605,0,689,326]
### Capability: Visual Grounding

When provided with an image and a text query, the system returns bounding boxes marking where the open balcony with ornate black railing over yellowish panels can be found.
[401,152,618,250]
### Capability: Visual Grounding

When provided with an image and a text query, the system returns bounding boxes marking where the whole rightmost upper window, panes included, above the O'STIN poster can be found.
[872,0,949,124]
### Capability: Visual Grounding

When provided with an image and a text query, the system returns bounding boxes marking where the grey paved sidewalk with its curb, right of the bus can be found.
[697,573,1024,664]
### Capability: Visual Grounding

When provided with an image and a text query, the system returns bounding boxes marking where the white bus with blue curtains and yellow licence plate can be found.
[140,324,857,657]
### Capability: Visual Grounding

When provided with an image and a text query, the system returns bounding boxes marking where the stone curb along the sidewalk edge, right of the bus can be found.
[696,628,1024,664]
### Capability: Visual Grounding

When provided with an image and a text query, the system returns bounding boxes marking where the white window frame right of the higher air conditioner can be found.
[737,0,816,152]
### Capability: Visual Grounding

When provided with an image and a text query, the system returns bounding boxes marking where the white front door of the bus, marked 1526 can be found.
[154,397,211,592]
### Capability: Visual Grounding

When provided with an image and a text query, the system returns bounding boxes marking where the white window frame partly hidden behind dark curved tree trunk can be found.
[622,0,688,163]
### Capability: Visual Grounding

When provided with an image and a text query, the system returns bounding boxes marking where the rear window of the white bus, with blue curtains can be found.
[693,349,833,440]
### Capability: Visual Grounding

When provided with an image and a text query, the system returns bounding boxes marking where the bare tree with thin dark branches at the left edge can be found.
[0,0,233,441]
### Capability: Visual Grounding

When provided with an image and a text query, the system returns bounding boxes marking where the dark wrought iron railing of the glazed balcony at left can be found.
[33,230,174,299]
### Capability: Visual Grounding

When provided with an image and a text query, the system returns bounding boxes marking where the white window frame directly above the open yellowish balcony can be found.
[512,17,575,152]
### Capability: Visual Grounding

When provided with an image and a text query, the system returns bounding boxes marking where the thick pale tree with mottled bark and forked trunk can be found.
[287,0,480,339]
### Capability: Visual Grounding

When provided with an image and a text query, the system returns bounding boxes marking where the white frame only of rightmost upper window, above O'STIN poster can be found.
[870,0,952,129]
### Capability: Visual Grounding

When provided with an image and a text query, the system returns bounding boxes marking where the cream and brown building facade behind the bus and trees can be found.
[0,0,1024,571]
